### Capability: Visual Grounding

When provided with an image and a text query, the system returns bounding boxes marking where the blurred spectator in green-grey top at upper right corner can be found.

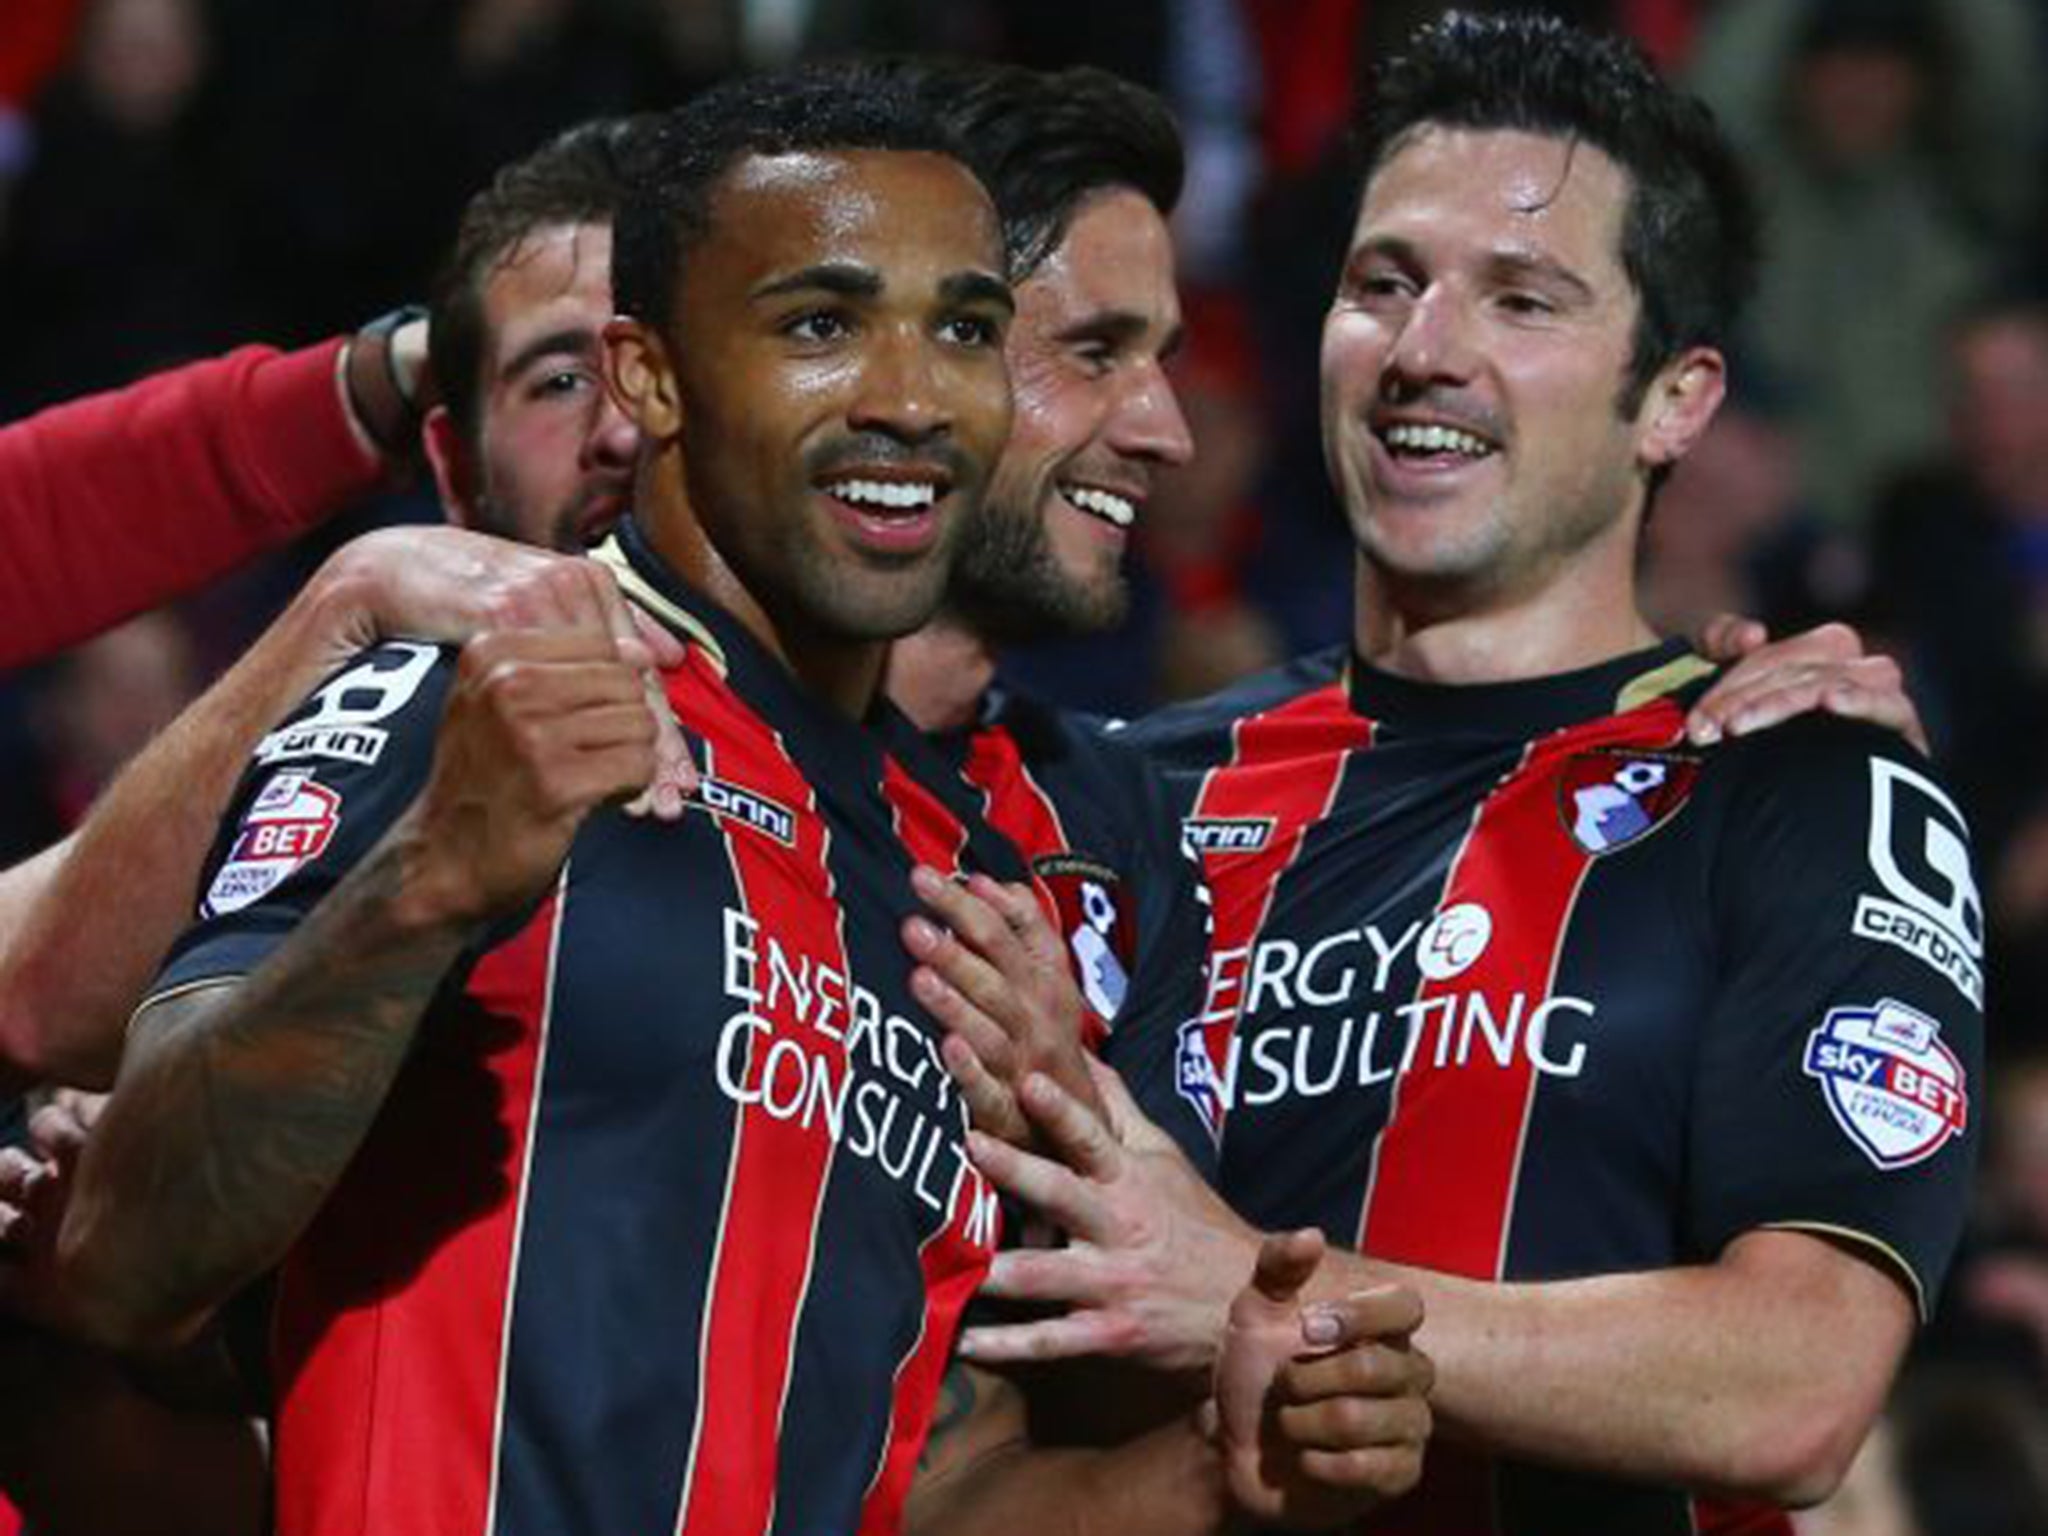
[1692,0,2042,524]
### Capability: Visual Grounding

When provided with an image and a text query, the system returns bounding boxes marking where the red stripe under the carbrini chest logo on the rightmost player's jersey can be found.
[1188,682,1372,1122]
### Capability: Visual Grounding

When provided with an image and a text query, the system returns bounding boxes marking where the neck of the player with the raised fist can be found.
[635,457,889,721]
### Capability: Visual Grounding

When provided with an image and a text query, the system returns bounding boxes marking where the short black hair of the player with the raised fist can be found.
[612,61,969,332]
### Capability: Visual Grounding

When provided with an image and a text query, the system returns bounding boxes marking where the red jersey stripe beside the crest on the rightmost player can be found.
[1358,707,1679,1534]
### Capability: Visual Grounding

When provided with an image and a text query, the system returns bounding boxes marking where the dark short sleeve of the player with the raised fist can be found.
[150,641,455,1001]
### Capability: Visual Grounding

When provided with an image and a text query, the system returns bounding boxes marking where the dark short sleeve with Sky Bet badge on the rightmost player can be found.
[1686,721,1985,1315]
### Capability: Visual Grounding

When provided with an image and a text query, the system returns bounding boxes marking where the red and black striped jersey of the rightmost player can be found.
[1126,645,1982,1536]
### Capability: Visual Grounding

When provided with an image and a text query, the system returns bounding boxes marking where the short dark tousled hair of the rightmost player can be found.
[1358,10,1757,412]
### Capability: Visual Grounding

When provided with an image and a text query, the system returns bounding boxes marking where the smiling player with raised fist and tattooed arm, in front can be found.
[66,72,1024,1536]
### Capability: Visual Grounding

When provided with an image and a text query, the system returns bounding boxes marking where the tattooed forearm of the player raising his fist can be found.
[66,838,479,1331]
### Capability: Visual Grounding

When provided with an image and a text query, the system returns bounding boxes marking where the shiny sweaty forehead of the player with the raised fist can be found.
[692,150,999,270]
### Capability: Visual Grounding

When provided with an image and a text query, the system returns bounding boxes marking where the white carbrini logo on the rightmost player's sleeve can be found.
[1851,758,1985,1008]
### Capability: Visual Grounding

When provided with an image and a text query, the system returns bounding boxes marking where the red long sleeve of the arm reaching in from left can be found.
[0,340,383,668]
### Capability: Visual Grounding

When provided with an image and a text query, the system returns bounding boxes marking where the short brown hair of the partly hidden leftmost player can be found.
[428,117,649,442]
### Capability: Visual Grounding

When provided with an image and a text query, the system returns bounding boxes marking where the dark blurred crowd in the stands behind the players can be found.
[0,0,2048,1536]
